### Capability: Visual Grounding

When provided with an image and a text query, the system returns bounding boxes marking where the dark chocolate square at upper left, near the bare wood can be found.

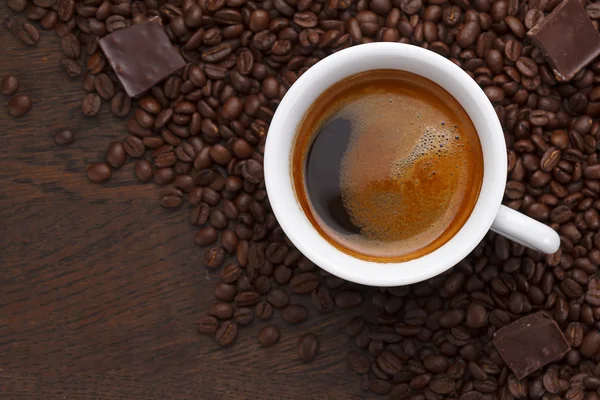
[99,22,185,97]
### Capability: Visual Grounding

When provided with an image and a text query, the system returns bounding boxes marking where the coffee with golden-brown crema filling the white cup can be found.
[293,70,483,262]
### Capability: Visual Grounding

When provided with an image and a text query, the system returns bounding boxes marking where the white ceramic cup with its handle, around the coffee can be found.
[264,43,560,286]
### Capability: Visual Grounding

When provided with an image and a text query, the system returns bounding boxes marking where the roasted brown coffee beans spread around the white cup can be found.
[2,0,600,400]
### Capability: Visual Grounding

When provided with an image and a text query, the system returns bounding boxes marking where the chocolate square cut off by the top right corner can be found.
[527,0,600,81]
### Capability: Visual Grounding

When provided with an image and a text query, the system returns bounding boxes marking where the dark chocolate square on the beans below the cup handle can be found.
[493,311,570,379]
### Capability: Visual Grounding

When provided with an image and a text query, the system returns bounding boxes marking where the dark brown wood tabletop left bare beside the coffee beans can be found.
[0,5,378,400]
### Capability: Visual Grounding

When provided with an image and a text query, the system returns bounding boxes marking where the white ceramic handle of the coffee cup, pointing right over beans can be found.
[491,205,560,254]
